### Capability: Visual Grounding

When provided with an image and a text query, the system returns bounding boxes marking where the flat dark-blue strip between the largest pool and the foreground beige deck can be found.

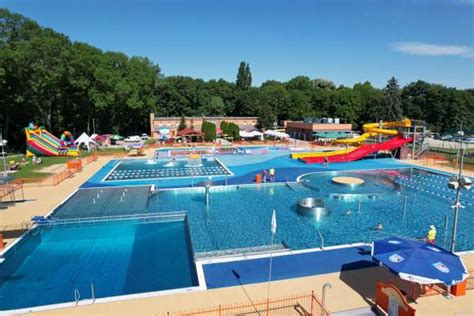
[203,246,375,289]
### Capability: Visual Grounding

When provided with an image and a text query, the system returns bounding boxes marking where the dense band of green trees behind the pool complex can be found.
[0,9,474,149]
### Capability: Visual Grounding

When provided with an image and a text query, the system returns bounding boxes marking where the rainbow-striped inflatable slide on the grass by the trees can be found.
[25,128,79,157]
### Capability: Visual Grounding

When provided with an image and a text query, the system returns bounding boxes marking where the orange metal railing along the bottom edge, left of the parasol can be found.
[172,292,329,316]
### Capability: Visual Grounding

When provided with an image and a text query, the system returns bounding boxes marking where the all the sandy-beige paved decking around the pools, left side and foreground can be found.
[0,150,474,315]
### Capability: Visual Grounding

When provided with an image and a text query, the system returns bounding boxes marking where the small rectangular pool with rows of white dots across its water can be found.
[104,158,232,181]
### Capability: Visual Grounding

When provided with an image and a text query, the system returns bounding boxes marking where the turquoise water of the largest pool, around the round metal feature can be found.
[149,168,474,252]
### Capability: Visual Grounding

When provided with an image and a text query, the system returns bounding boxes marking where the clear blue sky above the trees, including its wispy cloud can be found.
[0,0,474,88]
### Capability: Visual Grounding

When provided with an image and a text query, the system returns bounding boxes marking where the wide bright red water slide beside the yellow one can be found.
[300,135,413,163]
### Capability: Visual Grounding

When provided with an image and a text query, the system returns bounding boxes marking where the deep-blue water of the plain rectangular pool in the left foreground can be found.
[0,219,198,310]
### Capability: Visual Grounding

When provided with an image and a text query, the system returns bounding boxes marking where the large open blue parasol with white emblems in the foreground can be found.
[372,237,468,286]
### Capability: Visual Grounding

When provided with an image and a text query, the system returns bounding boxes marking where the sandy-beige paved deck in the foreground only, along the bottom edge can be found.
[30,255,474,316]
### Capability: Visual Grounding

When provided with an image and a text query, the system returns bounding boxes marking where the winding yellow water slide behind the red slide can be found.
[291,119,411,159]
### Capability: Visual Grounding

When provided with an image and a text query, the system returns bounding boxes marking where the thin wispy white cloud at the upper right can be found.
[391,42,474,58]
